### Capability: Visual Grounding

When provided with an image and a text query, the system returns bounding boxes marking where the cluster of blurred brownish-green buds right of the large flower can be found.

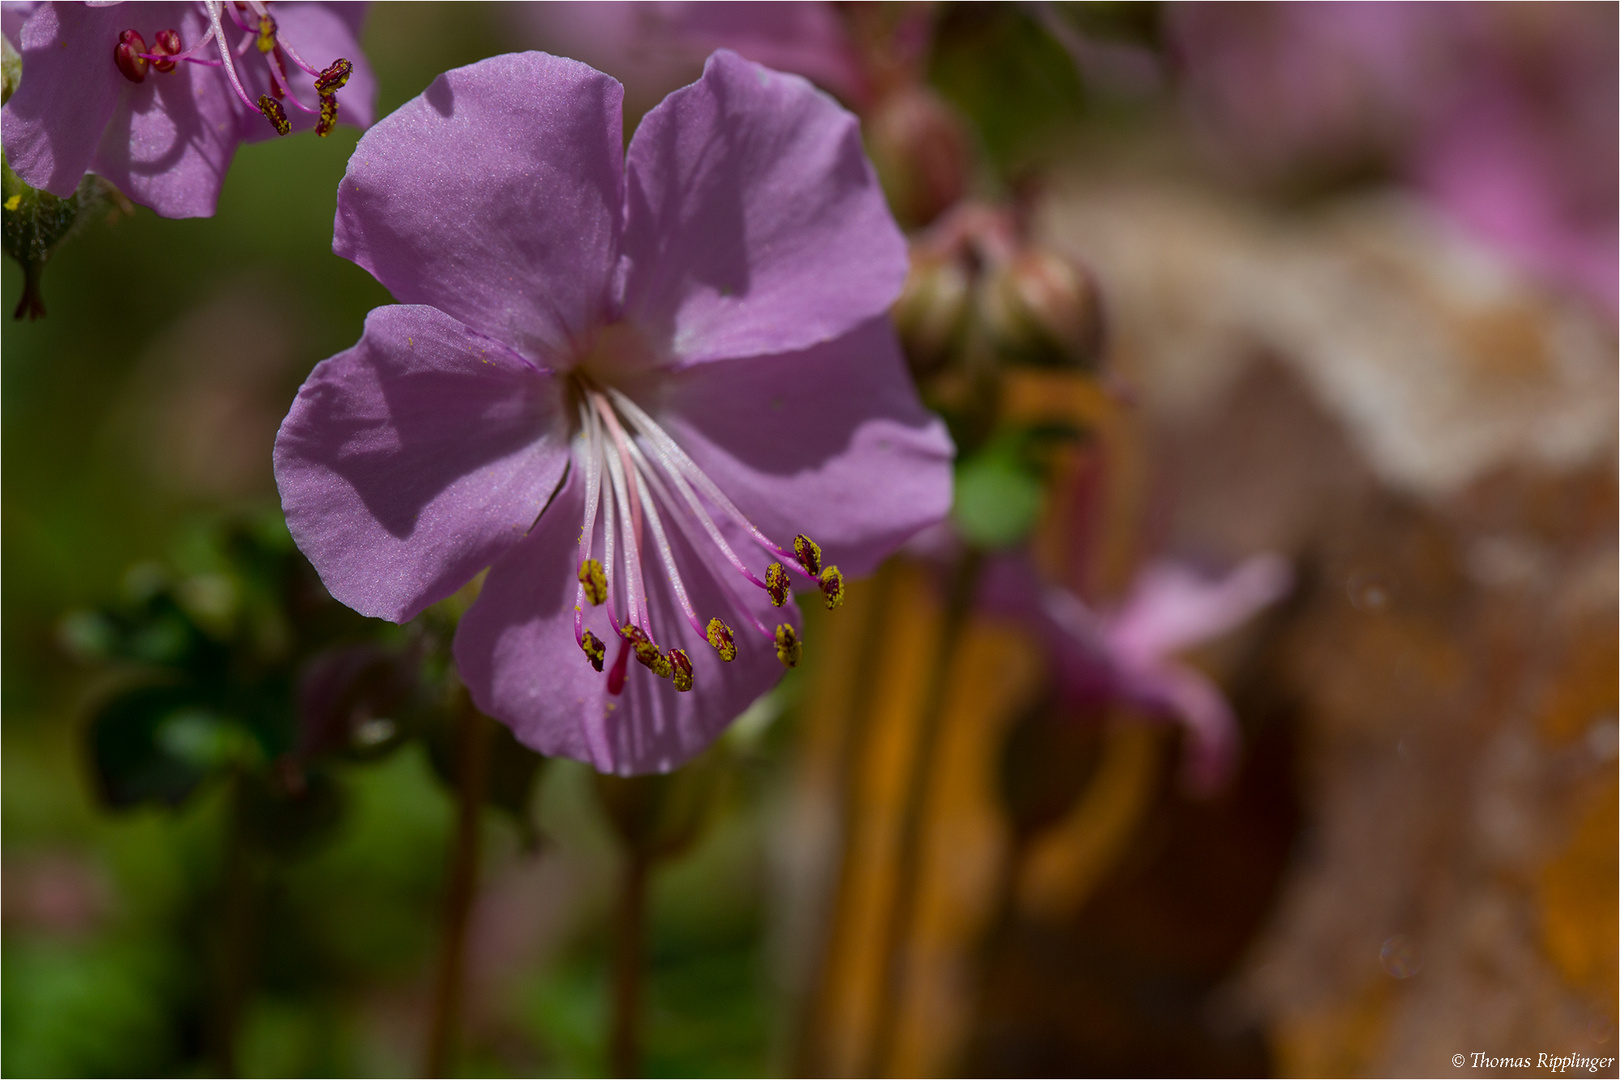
[894,202,1103,377]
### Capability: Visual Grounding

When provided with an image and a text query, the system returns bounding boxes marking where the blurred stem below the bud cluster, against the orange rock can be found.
[855,547,983,1077]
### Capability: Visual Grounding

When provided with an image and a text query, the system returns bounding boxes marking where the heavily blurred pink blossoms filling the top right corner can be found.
[1168,3,1620,311]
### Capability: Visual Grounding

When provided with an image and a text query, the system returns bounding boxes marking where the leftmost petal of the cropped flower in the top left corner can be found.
[0,3,125,198]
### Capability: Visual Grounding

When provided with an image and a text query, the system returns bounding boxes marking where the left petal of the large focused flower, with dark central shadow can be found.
[275,306,567,622]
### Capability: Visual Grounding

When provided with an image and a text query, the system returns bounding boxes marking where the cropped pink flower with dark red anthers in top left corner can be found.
[3,0,376,217]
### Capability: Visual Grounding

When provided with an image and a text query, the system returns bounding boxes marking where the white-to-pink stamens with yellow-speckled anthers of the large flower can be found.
[569,369,844,695]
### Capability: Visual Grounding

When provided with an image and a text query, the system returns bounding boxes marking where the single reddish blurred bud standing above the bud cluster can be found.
[867,84,972,227]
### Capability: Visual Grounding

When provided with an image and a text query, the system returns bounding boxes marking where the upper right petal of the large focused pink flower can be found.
[624,50,907,363]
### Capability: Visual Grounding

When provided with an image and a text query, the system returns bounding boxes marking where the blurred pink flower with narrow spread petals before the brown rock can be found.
[982,555,1293,792]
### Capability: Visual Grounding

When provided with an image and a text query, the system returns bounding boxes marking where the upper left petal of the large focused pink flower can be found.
[332,52,624,356]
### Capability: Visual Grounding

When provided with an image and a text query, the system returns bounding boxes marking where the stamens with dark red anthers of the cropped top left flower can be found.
[112,0,355,136]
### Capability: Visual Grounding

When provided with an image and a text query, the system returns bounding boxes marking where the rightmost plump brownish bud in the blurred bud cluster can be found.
[978,248,1102,368]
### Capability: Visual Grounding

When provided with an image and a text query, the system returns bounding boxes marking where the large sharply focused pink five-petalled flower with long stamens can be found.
[275,52,953,772]
